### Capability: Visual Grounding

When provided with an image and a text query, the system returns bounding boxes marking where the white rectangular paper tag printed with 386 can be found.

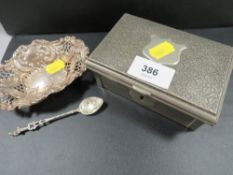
[127,56,176,89]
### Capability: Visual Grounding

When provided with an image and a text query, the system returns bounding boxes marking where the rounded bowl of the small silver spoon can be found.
[79,97,104,115]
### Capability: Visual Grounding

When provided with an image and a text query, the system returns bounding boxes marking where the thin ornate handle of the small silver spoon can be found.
[8,108,79,136]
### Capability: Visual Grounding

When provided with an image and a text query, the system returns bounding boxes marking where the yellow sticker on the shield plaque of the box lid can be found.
[149,41,175,60]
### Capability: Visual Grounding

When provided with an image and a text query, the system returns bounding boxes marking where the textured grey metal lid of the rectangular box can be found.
[88,14,233,124]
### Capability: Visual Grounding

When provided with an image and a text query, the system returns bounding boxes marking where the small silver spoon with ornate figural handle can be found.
[8,97,104,136]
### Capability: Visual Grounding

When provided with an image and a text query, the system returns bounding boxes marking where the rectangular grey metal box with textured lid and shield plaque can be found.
[87,14,233,129]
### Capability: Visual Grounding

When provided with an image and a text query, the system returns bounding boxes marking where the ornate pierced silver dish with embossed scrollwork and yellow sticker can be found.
[0,36,89,110]
